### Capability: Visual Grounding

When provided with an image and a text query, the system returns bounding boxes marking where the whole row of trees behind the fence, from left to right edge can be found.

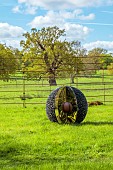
[0,26,113,85]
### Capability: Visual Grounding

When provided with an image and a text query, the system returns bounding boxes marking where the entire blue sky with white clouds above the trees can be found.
[0,0,113,52]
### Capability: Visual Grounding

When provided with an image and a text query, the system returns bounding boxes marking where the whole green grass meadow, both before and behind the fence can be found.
[0,72,113,170]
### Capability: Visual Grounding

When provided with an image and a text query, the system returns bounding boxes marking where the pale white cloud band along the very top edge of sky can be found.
[18,0,113,10]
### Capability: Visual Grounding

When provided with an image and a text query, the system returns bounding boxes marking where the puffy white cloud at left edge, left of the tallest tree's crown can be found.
[0,23,25,48]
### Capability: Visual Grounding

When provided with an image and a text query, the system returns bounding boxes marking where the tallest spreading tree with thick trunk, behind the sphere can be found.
[21,26,85,85]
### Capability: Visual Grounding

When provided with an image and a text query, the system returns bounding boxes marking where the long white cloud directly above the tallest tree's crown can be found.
[28,9,95,28]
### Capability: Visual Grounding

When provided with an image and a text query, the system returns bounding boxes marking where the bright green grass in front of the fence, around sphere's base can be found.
[0,105,113,170]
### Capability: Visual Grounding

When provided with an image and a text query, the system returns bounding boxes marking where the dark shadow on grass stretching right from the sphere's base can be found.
[80,121,113,126]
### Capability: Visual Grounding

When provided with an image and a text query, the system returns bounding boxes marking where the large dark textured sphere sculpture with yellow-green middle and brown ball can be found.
[46,86,88,123]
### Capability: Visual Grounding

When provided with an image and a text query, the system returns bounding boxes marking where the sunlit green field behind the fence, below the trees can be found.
[0,70,113,106]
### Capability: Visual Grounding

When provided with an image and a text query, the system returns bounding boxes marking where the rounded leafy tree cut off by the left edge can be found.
[0,44,17,81]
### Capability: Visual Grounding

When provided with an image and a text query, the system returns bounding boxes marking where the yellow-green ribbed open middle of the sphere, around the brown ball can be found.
[55,86,77,123]
